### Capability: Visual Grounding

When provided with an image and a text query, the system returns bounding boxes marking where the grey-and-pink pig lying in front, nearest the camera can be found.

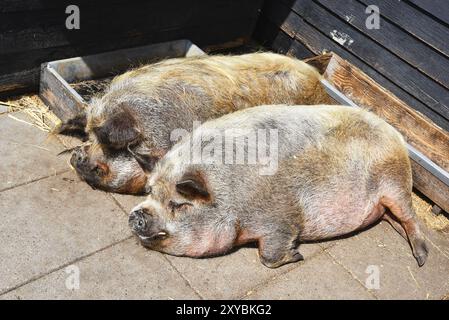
[129,105,428,268]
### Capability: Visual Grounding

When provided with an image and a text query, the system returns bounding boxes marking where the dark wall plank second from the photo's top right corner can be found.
[359,0,449,57]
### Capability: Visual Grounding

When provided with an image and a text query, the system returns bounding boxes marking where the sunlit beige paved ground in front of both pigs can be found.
[0,110,449,299]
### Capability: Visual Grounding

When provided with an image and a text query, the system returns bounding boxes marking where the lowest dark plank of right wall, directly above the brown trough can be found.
[265,0,449,130]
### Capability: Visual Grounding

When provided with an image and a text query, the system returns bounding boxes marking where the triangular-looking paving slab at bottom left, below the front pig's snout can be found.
[0,238,199,299]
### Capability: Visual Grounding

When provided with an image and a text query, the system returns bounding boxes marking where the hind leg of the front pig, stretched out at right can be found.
[380,197,428,267]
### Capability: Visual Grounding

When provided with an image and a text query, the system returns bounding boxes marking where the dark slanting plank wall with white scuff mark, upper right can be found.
[255,0,449,130]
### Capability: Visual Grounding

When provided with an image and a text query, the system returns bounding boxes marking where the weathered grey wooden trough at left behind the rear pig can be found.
[39,40,204,124]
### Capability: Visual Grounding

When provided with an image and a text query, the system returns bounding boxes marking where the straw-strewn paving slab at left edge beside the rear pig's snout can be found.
[0,112,69,190]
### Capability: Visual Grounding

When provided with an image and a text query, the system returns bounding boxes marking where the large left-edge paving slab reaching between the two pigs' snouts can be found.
[0,172,131,293]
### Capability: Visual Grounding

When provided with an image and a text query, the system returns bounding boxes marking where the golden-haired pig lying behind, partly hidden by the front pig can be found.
[70,52,332,194]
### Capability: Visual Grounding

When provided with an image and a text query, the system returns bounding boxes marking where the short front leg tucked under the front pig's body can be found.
[259,233,304,268]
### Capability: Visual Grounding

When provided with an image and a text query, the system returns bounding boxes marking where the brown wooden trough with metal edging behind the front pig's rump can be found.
[306,53,449,212]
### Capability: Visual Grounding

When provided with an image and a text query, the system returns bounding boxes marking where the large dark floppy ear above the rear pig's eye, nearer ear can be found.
[93,109,140,149]
